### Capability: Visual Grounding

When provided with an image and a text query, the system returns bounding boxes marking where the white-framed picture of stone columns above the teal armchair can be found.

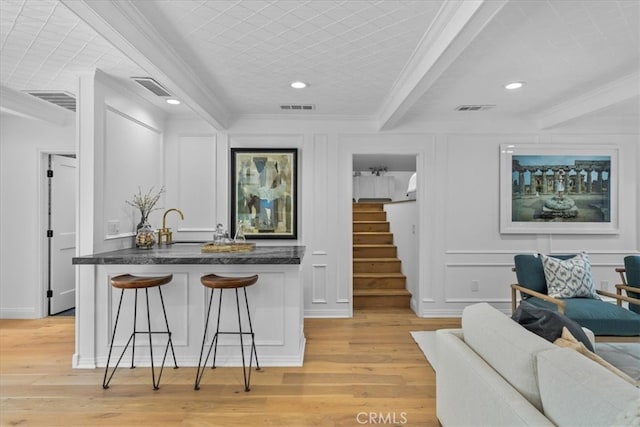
[500,144,619,234]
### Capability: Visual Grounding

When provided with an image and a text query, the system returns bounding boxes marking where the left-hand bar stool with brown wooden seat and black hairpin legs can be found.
[102,274,178,390]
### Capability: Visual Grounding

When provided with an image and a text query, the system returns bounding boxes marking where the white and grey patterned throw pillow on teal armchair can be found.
[540,252,598,298]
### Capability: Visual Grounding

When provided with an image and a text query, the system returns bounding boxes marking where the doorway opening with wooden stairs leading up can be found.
[352,154,417,310]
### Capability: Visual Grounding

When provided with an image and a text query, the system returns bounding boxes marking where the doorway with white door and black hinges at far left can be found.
[42,153,77,316]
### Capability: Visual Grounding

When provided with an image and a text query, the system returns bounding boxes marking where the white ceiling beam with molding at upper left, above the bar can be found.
[61,0,231,130]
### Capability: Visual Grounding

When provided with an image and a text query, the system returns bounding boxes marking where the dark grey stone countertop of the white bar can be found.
[73,242,305,264]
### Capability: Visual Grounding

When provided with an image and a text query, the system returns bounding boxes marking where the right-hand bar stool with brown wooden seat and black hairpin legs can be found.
[194,274,260,391]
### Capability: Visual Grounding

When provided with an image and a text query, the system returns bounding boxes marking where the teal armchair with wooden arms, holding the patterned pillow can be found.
[511,254,640,341]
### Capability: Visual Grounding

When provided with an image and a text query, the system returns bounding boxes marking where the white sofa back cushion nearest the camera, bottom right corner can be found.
[537,348,638,426]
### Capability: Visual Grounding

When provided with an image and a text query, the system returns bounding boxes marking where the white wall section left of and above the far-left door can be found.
[0,114,76,318]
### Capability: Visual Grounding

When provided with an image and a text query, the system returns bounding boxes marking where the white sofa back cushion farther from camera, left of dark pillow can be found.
[462,303,556,410]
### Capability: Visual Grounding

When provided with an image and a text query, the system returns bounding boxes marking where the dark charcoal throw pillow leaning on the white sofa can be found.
[511,301,594,351]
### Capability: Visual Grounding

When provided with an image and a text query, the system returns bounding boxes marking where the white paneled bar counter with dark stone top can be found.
[72,242,305,368]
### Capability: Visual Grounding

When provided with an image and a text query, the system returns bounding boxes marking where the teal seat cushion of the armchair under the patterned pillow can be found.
[527,297,640,337]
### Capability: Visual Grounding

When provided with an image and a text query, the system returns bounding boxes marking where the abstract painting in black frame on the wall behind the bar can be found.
[230,148,298,239]
